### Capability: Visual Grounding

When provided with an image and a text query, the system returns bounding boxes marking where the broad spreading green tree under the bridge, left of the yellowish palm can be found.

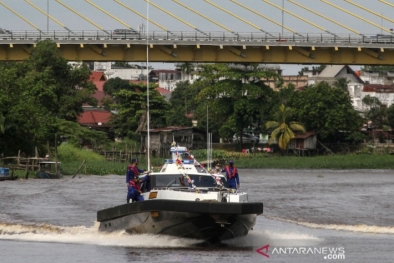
[193,64,278,147]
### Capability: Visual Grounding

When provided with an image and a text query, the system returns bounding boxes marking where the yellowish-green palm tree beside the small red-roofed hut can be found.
[265,104,305,150]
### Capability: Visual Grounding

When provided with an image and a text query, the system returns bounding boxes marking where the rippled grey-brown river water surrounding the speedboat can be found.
[0,169,394,263]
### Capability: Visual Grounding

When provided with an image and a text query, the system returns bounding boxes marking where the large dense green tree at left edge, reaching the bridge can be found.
[0,41,97,155]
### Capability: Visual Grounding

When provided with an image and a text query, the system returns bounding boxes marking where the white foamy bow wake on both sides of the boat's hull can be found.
[0,223,321,249]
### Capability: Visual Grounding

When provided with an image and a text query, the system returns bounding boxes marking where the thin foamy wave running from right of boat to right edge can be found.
[268,217,394,234]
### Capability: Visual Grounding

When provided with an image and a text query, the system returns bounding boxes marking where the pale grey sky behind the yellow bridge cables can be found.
[0,0,394,75]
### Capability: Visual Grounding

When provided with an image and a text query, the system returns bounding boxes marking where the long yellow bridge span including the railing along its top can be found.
[0,31,394,65]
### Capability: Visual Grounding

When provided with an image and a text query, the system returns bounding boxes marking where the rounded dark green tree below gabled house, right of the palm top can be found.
[288,82,362,141]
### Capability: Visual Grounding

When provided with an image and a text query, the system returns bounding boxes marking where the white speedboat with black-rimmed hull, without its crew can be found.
[97,146,263,243]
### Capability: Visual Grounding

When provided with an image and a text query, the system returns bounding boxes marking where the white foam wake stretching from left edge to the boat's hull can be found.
[0,223,198,248]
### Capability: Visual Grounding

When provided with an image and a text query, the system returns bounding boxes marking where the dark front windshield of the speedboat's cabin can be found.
[151,174,224,187]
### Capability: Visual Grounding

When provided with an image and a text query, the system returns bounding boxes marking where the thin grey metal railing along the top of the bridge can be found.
[0,30,394,44]
